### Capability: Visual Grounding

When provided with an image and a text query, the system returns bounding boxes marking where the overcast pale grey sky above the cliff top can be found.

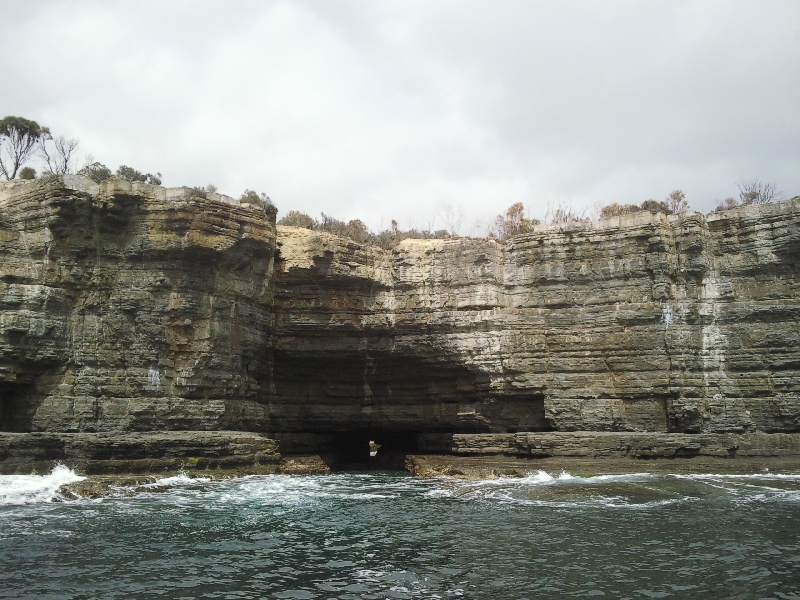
[0,0,800,235]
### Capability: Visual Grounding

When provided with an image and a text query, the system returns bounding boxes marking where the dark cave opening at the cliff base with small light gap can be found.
[330,430,418,470]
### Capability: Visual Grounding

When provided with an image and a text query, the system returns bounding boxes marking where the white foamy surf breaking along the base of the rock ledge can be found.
[6,465,800,510]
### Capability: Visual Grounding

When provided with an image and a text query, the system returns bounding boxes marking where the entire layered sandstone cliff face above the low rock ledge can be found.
[0,177,800,443]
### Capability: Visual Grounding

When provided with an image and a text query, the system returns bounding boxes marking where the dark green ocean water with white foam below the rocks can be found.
[0,467,800,599]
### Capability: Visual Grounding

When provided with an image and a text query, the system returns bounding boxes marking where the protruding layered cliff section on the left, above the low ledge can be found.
[0,176,275,431]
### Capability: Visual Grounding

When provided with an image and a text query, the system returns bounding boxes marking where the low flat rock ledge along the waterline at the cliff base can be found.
[0,431,800,499]
